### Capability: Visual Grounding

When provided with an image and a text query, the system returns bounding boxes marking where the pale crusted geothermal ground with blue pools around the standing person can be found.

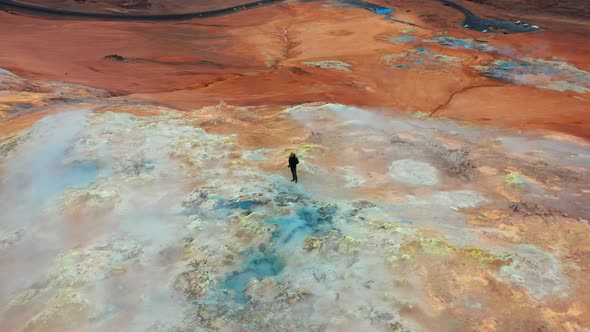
[0,94,590,331]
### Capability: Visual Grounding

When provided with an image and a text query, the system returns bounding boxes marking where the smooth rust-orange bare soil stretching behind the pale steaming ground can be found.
[0,1,590,138]
